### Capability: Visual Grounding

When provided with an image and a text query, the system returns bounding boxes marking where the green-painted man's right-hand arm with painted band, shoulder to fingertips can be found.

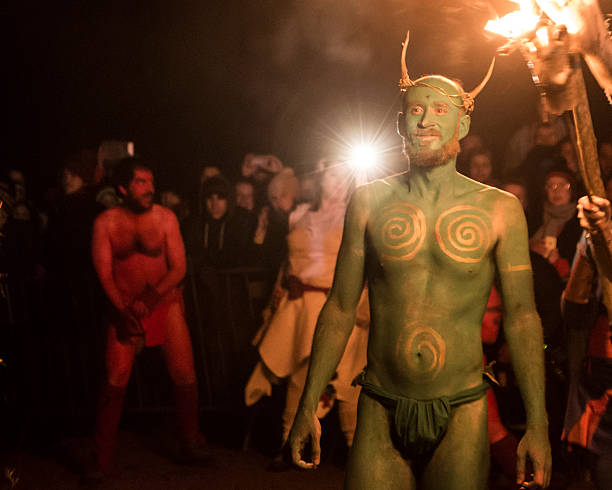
[495,197,551,487]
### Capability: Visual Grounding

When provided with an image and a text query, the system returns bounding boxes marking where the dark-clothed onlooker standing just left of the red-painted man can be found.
[42,150,105,422]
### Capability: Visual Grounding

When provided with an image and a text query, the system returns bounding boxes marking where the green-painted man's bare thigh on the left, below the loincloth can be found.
[344,393,416,490]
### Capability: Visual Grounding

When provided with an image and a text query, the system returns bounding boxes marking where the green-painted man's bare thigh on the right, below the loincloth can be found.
[421,397,489,490]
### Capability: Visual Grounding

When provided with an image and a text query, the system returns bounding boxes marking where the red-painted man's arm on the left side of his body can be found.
[91,213,128,311]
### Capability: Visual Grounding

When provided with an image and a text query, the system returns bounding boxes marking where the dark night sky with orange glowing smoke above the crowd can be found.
[2,0,612,193]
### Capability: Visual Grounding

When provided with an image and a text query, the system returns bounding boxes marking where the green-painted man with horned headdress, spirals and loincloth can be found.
[290,32,551,490]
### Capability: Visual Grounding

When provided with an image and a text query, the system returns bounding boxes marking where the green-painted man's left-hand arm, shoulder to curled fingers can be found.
[289,188,368,468]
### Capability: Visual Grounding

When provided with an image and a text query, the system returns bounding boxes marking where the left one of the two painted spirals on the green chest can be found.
[377,204,426,260]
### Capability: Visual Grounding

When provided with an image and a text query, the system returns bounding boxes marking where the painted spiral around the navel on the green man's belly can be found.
[397,327,446,381]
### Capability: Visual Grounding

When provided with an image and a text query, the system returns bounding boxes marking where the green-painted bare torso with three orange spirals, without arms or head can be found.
[365,174,501,398]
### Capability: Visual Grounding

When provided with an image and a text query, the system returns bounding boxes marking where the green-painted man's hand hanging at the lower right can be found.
[516,426,552,488]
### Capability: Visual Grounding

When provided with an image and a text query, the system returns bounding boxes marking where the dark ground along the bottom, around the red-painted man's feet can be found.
[0,412,592,490]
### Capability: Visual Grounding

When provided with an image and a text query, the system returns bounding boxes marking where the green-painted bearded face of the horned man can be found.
[402,78,462,167]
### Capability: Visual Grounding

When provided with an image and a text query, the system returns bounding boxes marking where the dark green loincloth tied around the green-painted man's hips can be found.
[354,373,490,458]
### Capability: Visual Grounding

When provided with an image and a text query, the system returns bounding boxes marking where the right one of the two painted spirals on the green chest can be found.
[436,205,491,263]
